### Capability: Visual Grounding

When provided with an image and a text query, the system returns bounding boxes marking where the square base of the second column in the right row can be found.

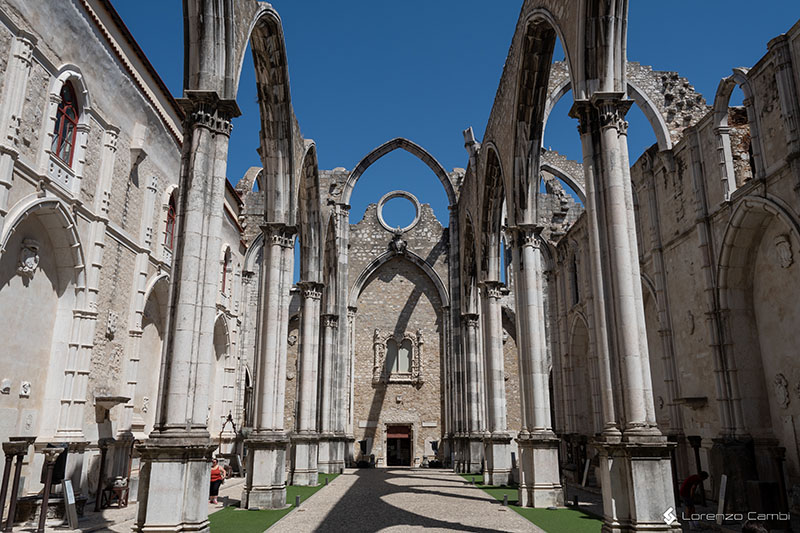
[517,431,564,508]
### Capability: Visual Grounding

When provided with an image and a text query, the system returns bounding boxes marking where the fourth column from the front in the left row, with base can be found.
[318,314,339,474]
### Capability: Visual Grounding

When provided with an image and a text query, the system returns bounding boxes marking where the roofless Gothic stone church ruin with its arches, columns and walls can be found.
[0,0,800,532]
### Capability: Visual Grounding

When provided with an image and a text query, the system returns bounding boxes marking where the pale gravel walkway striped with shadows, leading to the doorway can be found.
[269,468,543,533]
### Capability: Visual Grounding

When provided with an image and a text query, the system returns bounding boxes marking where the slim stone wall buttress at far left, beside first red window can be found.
[0,32,36,229]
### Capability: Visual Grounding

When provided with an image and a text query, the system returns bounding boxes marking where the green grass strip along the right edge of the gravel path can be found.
[461,474,603,533]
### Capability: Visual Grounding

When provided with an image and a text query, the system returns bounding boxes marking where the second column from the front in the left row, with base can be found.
[242,224,295,509]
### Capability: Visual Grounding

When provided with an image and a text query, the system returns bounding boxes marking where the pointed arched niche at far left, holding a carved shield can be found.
[0,195,88,438]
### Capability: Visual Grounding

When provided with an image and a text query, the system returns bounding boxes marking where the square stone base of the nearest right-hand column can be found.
[592,437,681,533]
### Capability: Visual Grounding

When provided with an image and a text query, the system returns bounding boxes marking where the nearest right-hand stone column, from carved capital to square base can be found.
[573,93,680,533]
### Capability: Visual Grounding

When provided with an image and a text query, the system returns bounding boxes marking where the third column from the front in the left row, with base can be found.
[292,282,322,485]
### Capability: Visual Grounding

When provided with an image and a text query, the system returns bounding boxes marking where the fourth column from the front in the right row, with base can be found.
[461,313,483,474]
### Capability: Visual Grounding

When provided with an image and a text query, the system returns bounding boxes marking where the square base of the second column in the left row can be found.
[242,432,289,510]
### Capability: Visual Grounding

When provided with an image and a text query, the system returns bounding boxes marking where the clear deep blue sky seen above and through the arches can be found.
[113,0,800,225]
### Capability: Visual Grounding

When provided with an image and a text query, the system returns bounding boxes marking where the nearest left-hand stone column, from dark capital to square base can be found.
[136,91,234,533]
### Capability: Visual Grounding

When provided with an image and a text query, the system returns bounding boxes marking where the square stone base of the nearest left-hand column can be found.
[134,432,217,533]
